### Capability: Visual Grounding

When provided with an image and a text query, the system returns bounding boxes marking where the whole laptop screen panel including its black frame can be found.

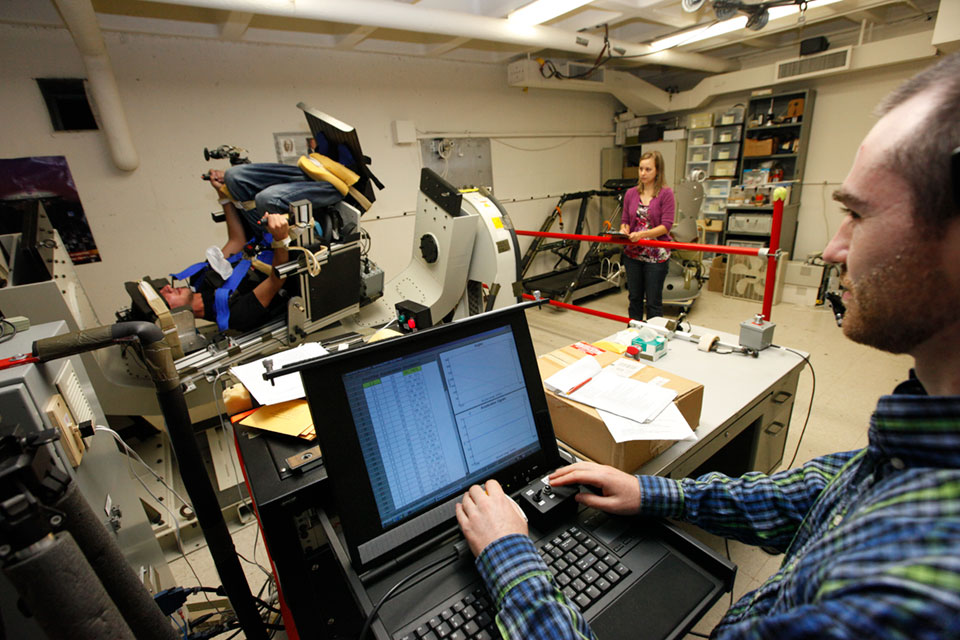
[301,307,560,568]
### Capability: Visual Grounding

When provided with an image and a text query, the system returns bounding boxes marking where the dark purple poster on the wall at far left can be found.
[0,156,100,264]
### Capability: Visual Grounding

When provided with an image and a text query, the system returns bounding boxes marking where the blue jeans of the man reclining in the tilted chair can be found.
[223,162,343,233]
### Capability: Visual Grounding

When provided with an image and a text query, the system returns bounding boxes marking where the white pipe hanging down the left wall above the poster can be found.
[53,0,140,171]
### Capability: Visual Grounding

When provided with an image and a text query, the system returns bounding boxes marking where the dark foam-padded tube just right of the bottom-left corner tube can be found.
[56,482,177,640]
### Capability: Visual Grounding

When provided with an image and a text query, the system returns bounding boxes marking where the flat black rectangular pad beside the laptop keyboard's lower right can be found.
[590,555,715,640]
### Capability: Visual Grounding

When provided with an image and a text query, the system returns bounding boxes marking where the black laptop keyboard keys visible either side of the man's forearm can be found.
[397,527,630,640]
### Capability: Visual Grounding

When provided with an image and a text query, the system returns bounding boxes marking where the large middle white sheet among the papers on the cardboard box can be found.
[566,369,677,422]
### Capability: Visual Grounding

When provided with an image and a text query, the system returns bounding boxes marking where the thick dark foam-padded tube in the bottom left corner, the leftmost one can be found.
[3,525,135,640]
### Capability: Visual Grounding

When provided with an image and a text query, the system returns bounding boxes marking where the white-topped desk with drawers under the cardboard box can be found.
[637,326,807,478]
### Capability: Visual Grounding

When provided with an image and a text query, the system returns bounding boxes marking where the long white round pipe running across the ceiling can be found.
[133,0,739,73]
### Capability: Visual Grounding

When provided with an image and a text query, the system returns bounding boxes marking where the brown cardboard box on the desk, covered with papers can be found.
[537,345,703,472]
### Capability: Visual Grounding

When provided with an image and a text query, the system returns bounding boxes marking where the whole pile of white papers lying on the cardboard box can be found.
[544,356,696,442]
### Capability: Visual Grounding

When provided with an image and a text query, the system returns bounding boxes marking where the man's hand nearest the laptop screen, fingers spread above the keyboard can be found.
[457,480,527,556]
